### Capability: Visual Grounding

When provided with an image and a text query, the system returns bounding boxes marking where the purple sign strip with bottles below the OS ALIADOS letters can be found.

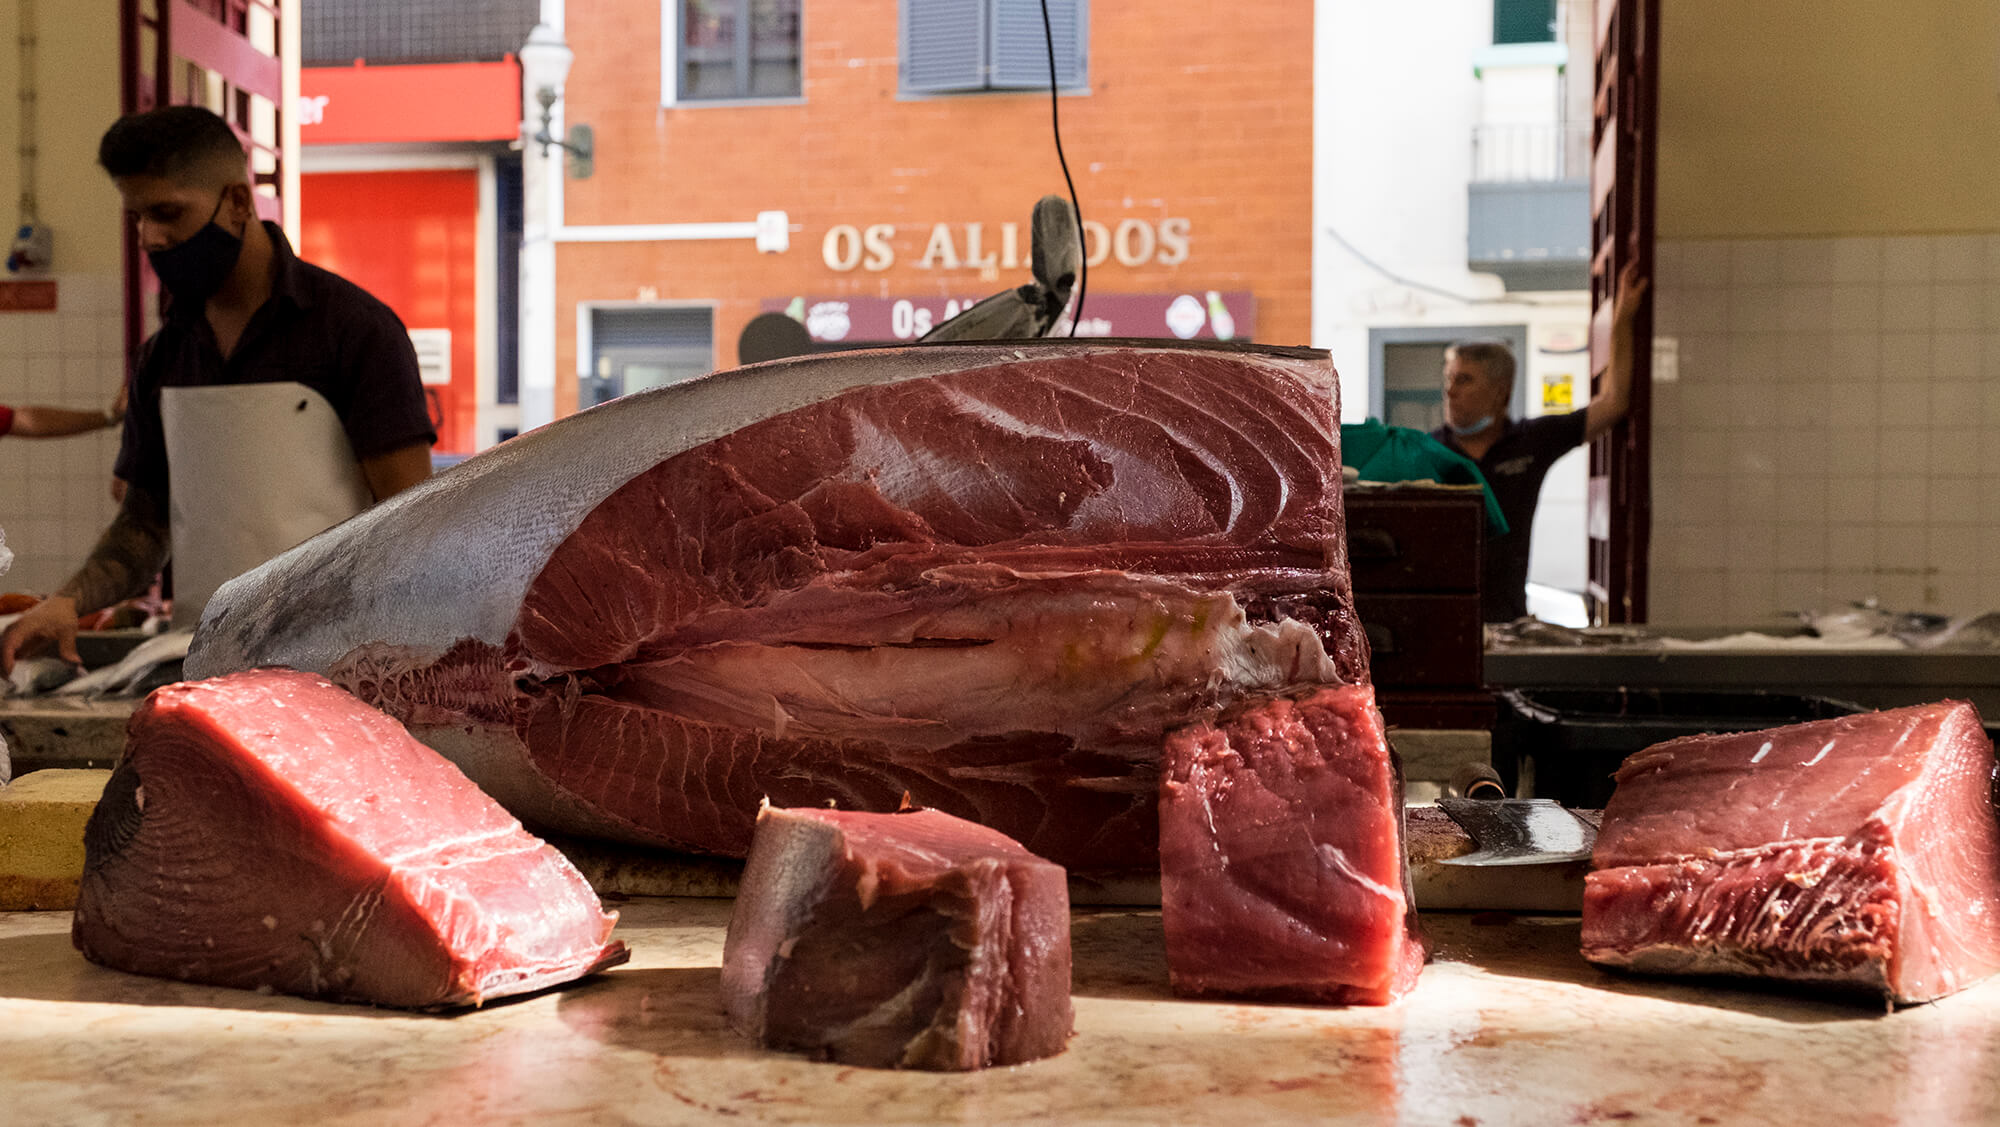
[762,290,1256,344]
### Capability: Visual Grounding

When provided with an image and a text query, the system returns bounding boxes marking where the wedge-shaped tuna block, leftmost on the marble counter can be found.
[72,669,626,1009]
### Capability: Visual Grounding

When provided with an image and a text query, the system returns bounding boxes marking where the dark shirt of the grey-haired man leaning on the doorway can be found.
[1430,412,1586,621]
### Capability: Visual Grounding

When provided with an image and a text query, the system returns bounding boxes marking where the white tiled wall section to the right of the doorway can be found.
[1650,234,2000,623]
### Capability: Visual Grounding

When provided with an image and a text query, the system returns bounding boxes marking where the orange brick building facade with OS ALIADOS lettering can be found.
[556,0,1312,414]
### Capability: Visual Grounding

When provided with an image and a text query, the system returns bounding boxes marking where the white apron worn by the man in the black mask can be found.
[160,384,374,629]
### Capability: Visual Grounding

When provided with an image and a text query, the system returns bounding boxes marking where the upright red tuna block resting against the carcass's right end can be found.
[1160,685,1424,1005]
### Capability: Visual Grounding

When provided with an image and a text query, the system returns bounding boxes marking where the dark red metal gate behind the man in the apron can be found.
[118,0,292,364]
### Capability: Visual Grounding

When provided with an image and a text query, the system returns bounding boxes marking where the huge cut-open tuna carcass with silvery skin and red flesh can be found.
[186,342,1368,871]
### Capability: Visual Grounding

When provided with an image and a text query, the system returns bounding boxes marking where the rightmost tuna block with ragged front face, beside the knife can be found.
[1584,701,2000,1003]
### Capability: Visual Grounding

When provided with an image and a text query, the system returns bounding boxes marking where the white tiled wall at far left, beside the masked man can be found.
[0,274,124,593]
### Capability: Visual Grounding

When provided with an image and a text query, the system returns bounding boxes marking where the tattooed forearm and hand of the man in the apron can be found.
[0,486,170,677]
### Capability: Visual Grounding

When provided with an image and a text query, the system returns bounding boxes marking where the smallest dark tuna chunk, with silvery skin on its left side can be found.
[722,805,1070,1069]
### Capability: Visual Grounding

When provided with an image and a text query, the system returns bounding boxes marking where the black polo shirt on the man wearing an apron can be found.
[114,222,438,508]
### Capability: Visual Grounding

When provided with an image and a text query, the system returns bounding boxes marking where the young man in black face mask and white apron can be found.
[0,106,436,675]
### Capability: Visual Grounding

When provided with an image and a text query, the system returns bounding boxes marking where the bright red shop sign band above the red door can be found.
[298,58,520,144]
